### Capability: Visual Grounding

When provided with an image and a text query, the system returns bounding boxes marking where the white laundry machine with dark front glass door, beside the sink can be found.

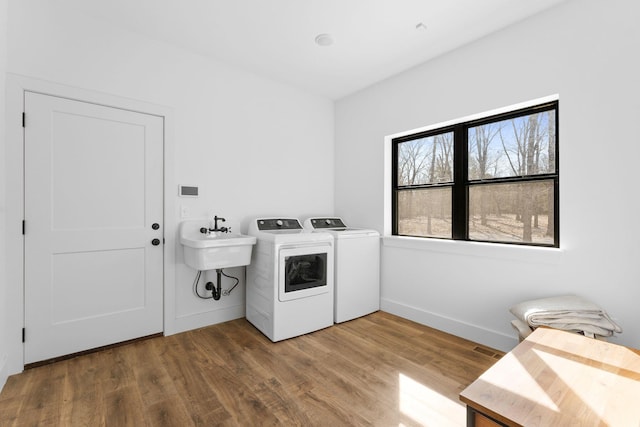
[246,218,334,342]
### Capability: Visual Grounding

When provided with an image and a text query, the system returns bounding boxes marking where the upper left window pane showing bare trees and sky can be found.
[398,132,453,186]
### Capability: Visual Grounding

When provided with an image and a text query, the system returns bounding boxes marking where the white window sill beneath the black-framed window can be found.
[382,236,565,264]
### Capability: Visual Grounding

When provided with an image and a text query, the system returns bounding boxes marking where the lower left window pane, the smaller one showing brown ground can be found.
[397,187,451,239]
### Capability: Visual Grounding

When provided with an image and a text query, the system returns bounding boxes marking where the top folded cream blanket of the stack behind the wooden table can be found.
[509,295,622,336]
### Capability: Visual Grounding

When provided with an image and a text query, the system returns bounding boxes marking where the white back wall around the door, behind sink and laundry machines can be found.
[0,0,334,374]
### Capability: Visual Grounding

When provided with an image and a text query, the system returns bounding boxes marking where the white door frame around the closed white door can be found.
[5,73,177,375]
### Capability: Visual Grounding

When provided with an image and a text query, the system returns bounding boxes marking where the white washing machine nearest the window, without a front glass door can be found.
[304,218,380,323]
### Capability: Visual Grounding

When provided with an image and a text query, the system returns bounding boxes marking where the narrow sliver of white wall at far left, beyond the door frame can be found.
[0,0,9,389]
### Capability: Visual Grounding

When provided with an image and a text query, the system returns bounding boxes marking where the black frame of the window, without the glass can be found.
[391,100,560,248]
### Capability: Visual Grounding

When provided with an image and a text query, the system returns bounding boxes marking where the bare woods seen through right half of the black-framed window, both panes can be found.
[468,110,556,244]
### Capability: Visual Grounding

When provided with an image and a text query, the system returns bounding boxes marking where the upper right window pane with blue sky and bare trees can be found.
[468,109,556,180]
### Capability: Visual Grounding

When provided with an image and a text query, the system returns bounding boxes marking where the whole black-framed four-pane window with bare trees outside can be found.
[392,101,559,247]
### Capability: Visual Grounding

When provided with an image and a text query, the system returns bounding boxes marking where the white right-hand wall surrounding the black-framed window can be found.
[335,0,640,349]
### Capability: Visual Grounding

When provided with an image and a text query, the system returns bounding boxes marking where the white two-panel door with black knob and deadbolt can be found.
[24,92,164,363]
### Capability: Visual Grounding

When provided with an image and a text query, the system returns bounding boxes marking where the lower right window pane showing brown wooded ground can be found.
[469,180,555,245]
